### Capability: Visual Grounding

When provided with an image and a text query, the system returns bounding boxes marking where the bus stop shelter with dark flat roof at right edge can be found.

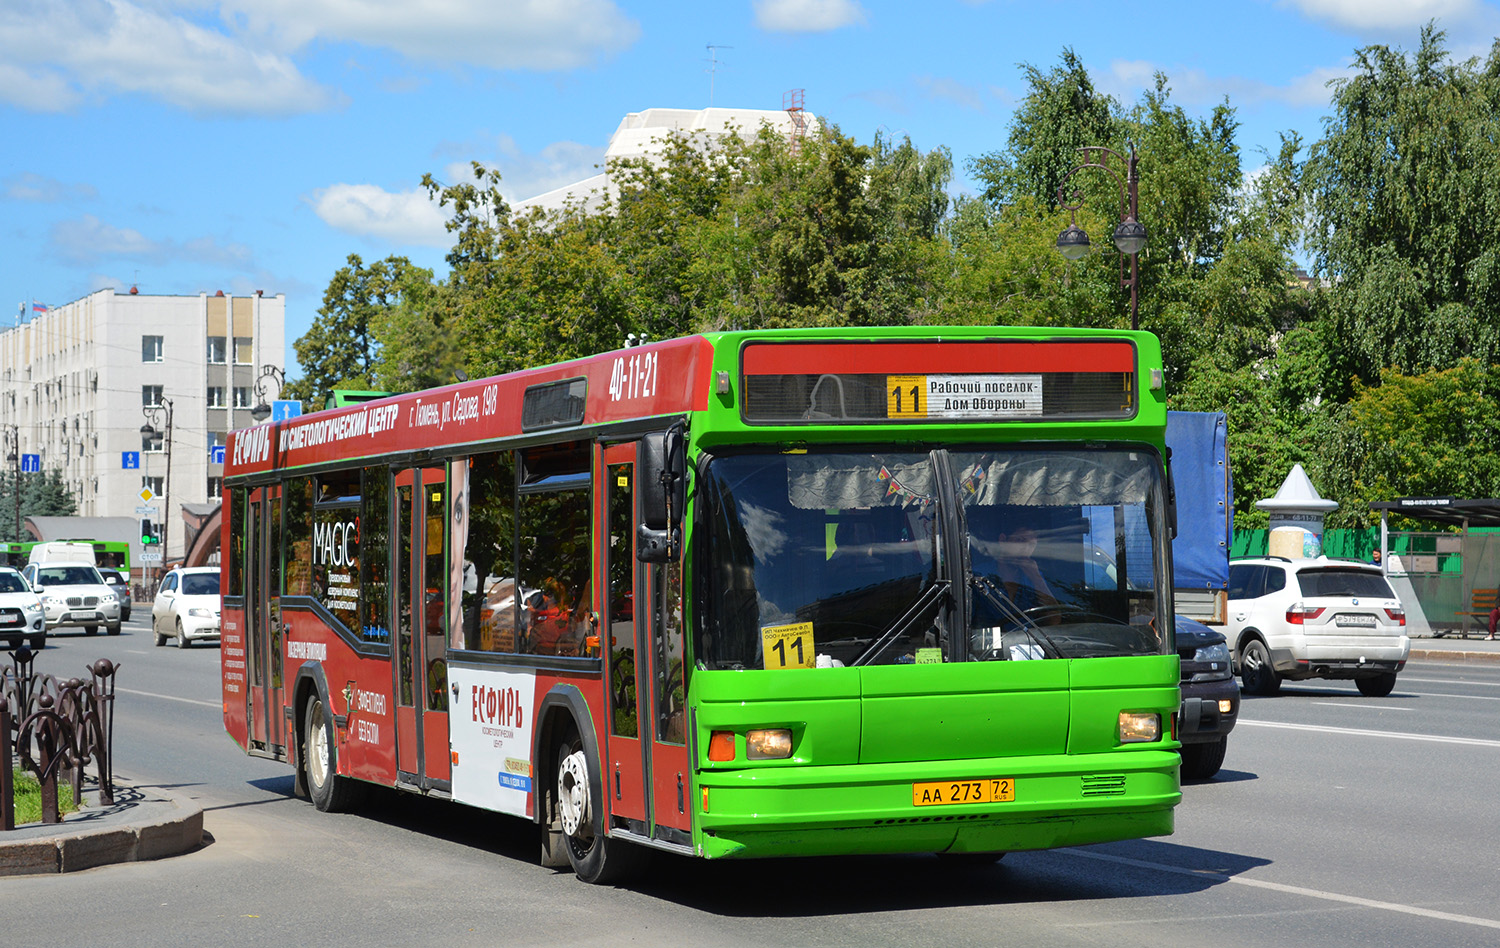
[1370,497,1500,638]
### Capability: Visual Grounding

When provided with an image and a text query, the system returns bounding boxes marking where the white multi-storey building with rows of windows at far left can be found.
[0,288,287,561]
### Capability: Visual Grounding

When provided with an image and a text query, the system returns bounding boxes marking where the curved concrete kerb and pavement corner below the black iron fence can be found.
[0,777,203,876]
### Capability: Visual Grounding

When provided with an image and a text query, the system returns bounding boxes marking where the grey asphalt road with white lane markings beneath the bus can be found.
[0,611,1500,948]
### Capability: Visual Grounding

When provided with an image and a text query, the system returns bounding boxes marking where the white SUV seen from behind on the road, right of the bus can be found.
[1224,557,1412,698]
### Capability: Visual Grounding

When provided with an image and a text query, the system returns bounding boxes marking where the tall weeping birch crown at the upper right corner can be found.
[1307,24,1500,381]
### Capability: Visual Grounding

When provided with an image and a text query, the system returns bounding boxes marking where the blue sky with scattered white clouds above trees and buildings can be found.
[0,0,1500,375]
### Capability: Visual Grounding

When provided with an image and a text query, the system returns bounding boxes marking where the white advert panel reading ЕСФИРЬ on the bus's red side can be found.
[449,666,536,816]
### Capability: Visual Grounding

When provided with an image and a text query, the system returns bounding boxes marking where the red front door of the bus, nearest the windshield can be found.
[596,443,690,843]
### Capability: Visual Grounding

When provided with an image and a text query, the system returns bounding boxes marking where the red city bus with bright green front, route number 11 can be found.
[222,327,1181,881]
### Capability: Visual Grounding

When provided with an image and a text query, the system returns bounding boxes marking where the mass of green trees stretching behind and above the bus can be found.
[288,27,1500,525]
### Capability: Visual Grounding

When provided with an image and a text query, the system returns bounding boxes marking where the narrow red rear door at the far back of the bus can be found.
[245,486,287,759]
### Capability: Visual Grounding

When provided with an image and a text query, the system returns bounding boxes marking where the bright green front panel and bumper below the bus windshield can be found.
[693,656,1181,858]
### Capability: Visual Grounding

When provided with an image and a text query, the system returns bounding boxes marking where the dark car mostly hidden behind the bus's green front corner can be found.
[1178,615,1239,780]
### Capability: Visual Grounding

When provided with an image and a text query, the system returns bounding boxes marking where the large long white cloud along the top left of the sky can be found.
[0,0,641,116]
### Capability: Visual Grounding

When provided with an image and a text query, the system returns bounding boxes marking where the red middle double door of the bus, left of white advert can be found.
[392,468,453,791]
